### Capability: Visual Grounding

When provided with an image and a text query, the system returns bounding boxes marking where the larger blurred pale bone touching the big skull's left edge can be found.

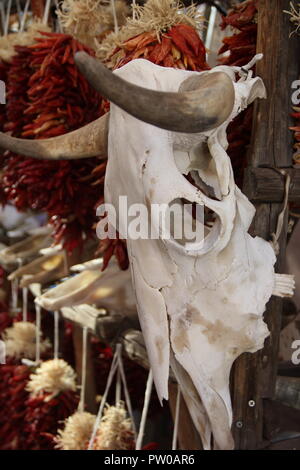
[35,263,136,314]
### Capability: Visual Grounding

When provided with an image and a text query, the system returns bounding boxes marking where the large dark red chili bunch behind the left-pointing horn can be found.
[3,33,102,251]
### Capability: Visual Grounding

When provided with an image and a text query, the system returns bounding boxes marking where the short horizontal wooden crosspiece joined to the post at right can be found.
[244,168,300,203]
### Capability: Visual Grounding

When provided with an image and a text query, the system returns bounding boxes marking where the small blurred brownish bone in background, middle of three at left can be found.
[8,250,69,287]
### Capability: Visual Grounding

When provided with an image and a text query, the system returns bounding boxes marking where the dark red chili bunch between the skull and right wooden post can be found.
[219,0,257,187]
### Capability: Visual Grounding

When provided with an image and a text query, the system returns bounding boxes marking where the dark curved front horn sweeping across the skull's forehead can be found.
[75,52,235,133]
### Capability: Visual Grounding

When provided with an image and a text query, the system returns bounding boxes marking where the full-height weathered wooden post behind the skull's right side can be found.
[232,0,300,449]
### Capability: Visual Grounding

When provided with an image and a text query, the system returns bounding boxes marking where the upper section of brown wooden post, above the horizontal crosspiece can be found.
[251,0,299,168]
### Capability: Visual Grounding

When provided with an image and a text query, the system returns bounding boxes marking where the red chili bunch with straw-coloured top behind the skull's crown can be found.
[97,0,210,269]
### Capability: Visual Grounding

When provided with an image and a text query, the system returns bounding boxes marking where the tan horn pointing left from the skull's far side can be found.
[0,114,108,160]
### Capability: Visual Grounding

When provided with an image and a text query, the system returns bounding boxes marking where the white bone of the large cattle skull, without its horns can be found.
[99,59,291,449]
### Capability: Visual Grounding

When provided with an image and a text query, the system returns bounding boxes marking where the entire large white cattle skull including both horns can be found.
[0,53,293,449]
